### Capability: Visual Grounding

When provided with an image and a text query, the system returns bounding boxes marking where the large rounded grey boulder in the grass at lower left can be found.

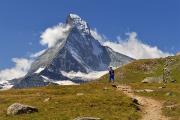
[7,103,38,115]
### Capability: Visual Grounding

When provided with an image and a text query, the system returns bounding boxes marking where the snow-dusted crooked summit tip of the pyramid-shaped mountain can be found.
[66,13,91,35]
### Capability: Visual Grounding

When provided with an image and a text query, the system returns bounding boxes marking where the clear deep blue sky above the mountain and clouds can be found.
[0,0,180,70]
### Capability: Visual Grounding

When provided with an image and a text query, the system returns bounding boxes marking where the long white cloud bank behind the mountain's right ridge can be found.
[92,30,172,59]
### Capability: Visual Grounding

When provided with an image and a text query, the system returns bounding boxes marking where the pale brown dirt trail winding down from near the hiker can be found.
[117,85,169,120]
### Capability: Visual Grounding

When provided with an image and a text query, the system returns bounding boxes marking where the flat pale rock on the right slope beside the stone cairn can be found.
[141,76,163,83]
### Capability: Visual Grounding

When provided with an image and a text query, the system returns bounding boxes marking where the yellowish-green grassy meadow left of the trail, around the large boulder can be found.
[0,82,140,120]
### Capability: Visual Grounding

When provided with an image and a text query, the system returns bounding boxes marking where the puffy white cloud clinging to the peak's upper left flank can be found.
[40,23,70,48]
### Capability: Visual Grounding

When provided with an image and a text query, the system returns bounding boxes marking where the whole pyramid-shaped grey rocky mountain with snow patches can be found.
[9,14,133,88]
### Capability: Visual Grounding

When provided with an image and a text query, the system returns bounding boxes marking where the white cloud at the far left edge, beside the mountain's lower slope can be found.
[0,58,32,83]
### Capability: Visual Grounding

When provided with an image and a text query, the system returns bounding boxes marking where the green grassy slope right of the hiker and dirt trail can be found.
[100,56,180,120]
